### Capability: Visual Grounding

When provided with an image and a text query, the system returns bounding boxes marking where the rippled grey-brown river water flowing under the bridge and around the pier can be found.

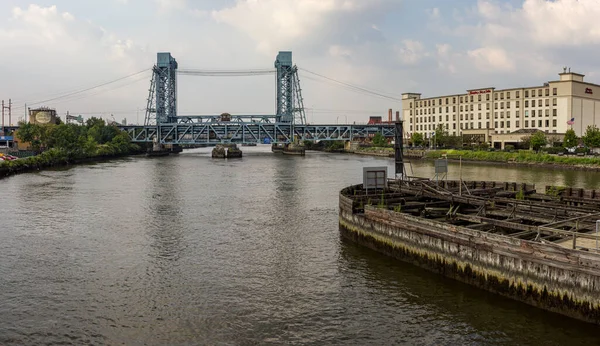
[0,146,600,345]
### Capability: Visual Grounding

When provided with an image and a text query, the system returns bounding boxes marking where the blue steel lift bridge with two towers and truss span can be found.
[121,52,395,146]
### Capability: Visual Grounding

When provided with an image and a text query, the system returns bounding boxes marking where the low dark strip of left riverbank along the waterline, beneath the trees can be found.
[0,144,145,179]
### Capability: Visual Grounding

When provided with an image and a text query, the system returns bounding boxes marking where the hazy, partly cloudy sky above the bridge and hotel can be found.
[0,0,600,123]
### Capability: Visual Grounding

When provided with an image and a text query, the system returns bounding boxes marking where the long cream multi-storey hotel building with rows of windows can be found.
[402,69,600,148]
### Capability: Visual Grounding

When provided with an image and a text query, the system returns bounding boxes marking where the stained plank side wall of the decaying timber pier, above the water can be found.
[339,194,600,324]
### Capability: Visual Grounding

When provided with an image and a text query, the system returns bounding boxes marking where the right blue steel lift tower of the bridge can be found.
[275,52,306,124]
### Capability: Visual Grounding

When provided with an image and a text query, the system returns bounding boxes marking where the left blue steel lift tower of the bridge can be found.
[144,53,177,125]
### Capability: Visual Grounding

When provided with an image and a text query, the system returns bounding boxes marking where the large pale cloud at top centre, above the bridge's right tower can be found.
[212,0,398,54]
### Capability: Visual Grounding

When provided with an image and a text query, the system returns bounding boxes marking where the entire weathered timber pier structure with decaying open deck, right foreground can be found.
[339,180,600,324]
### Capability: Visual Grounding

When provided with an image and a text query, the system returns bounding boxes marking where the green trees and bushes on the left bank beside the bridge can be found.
[0,118,145,179]
